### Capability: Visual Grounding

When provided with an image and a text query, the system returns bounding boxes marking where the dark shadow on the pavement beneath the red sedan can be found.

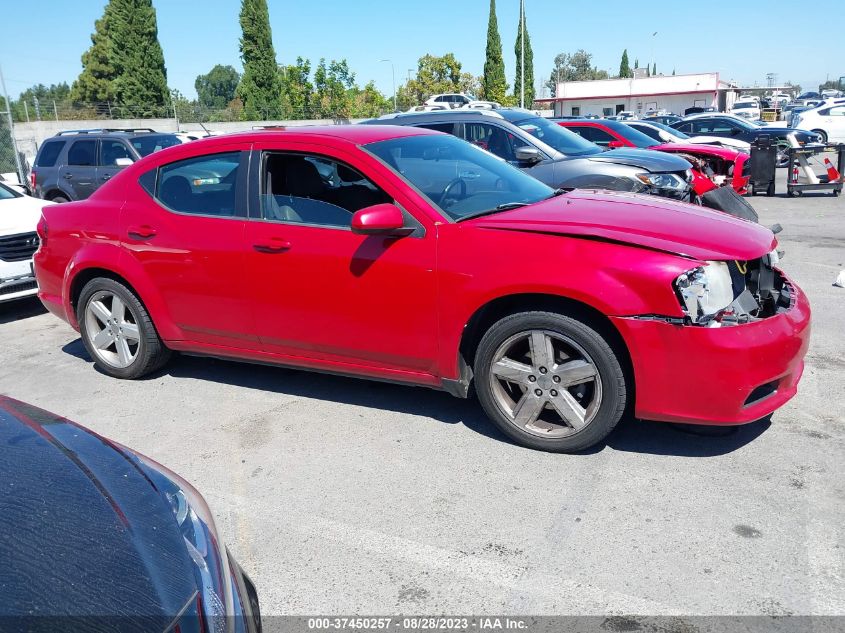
[62,338,771,457]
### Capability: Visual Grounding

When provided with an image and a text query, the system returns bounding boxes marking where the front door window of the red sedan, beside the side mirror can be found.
[261,152,393,229]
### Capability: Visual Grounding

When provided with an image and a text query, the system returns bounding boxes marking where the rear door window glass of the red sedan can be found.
[155,152,241,217]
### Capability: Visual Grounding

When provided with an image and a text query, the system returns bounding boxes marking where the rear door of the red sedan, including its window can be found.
[121,147,257,349]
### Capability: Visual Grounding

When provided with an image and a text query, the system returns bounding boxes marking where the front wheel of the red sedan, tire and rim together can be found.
[475,312,627,453]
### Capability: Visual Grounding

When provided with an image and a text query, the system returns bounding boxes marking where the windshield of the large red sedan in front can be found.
[365,134,555,220]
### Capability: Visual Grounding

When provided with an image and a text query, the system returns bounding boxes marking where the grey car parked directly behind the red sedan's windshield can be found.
[364,108,691,200]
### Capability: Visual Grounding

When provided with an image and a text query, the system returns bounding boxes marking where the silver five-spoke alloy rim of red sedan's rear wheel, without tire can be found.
[85,290,141,369]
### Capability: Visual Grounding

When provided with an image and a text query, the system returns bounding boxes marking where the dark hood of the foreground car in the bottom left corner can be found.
[0,396,196,631]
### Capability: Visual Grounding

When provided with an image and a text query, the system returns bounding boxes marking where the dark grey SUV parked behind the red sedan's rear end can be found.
[30,128,182,202]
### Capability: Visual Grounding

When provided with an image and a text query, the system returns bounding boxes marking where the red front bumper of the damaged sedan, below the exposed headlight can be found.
[612,284,810,425]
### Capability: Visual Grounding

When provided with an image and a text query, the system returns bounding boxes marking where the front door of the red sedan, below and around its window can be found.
[245,147,437,372]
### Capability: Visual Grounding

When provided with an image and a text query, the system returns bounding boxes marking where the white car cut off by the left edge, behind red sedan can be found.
[0,184,54,302]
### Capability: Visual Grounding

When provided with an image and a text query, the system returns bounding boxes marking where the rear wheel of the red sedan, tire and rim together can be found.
[77,277,171,379]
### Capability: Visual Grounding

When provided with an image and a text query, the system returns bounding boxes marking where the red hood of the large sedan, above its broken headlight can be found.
[466,189,777,260]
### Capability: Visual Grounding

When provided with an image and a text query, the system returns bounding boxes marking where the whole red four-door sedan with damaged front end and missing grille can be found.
[35,126,810,451]
